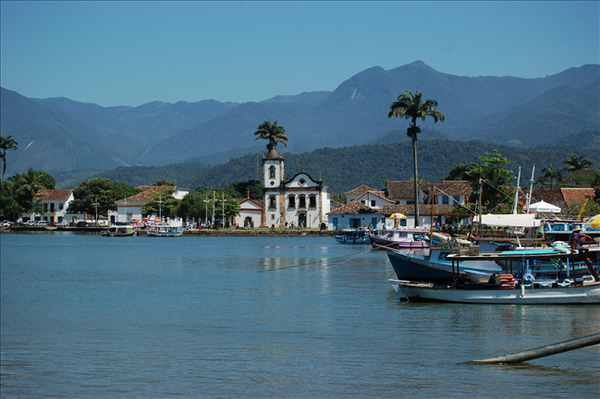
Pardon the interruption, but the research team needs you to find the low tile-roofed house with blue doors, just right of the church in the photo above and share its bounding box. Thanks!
[327,199,387,230]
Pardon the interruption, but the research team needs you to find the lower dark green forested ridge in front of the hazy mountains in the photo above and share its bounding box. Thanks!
[65,132,600,193]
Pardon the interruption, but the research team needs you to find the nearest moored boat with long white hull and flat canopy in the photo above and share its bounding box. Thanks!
[391,249,600,304]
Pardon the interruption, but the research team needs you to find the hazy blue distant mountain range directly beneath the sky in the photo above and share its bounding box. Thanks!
[0,61,600,176]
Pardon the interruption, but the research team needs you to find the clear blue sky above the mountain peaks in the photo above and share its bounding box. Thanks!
[0,0,600,106]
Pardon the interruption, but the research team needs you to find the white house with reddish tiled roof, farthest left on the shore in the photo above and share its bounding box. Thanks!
[21,190,85,224]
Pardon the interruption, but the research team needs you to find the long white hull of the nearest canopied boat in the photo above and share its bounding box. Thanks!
[399,282,600,305]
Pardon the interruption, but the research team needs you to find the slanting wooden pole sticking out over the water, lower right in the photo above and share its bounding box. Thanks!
[463,333,600,364]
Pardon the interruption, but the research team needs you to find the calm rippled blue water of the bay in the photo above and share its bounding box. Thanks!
[0,233,600,398]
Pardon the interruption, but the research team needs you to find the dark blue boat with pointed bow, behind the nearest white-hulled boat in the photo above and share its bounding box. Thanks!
[387,246,502,284]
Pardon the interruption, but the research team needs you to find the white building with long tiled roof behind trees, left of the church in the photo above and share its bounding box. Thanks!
[108,186,189,226]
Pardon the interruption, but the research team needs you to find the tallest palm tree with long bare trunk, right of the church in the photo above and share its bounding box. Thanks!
[388,90,446,226]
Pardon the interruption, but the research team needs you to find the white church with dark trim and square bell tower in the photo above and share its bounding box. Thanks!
[262,146,329,229]
